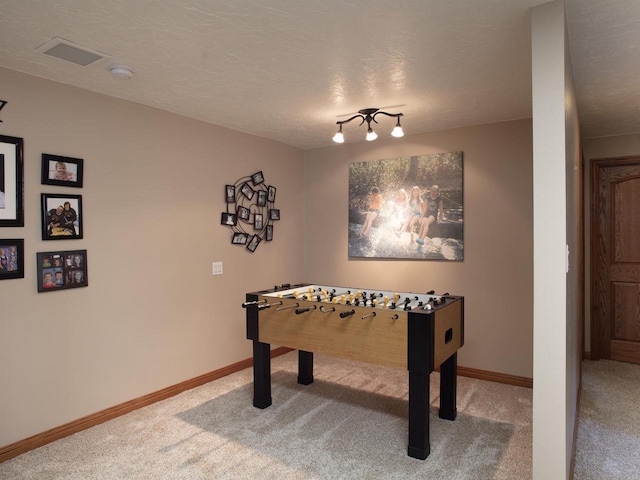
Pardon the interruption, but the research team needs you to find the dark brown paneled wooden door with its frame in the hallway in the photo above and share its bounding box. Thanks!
[591,157,640,363]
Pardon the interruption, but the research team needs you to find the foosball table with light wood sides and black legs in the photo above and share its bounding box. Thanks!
[242,284,464,460]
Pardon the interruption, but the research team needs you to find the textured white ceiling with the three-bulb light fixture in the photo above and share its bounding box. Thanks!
[0,0,640,149]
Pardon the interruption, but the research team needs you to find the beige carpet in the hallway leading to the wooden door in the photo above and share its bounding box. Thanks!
[574,360,640,480]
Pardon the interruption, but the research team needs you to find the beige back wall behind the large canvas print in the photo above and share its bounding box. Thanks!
[304,120,533,378]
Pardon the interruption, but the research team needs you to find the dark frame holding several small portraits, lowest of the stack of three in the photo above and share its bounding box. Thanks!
[36,250,89,292]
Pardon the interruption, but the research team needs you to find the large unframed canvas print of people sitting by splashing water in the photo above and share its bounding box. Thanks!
[348,152,464,261]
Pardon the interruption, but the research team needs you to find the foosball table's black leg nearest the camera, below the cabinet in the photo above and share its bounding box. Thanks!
[408,371,431,460]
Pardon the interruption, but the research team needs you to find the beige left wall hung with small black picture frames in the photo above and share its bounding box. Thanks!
[0,69,304,445]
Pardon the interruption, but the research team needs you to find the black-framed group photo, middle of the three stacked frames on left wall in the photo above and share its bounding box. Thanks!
[42,193,83,240]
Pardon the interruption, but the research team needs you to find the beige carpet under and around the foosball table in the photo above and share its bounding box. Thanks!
[0,352,536,480]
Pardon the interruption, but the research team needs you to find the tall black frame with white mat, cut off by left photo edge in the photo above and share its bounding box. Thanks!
[0,135,24,227]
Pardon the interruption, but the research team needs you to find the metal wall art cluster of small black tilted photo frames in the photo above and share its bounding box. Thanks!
[220,171,280,253]
